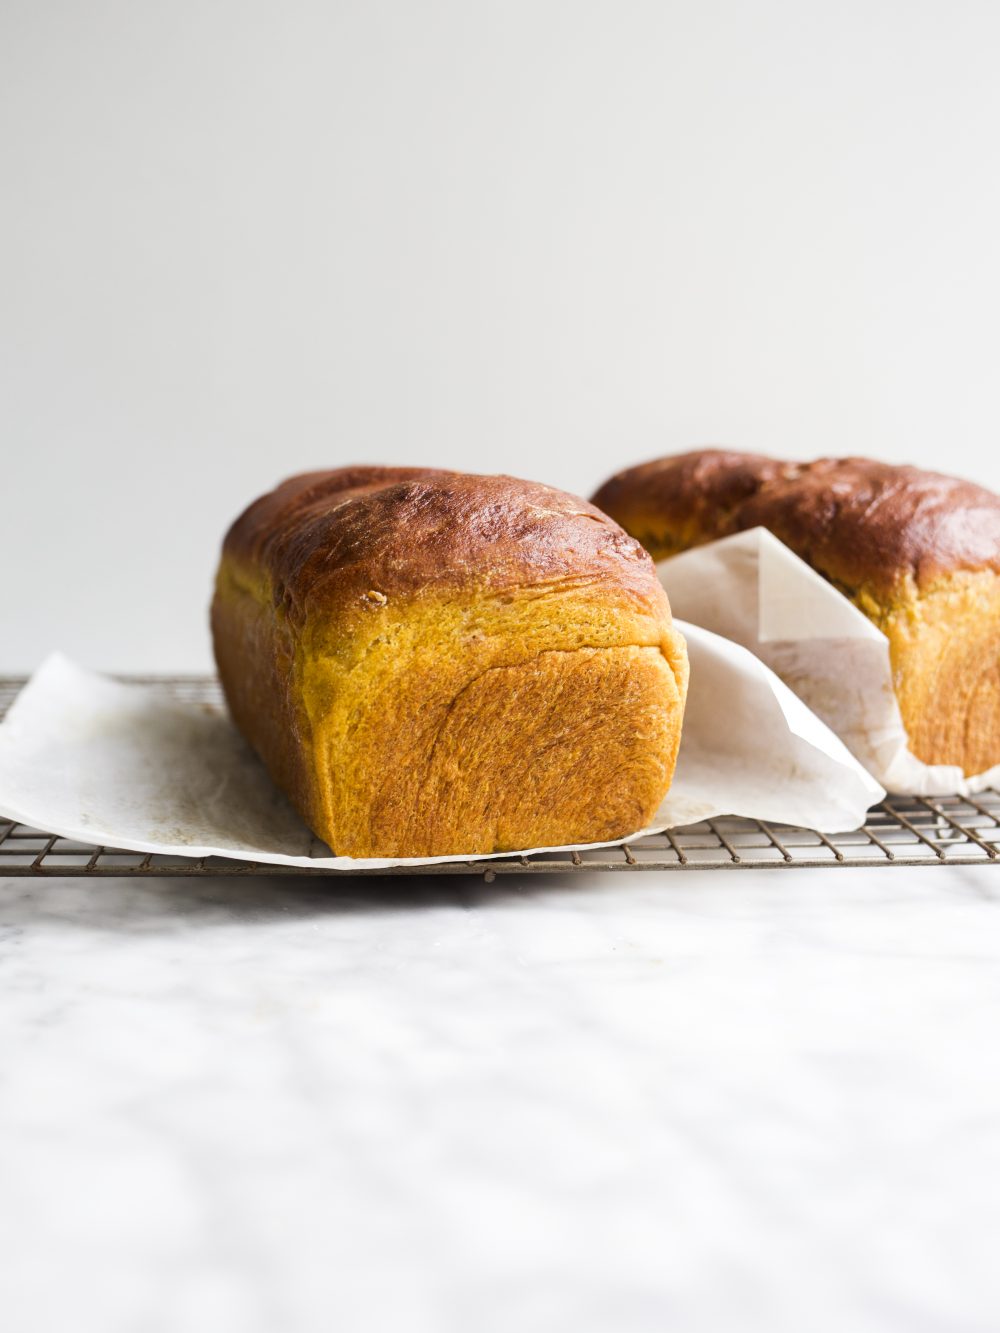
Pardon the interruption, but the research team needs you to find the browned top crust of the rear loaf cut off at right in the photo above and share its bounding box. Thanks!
[593,449,1000,592]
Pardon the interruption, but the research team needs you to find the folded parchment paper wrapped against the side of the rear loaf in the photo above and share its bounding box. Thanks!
[657,528,1000,796]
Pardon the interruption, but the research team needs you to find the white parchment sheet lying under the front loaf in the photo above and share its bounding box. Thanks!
[0,625,884,870]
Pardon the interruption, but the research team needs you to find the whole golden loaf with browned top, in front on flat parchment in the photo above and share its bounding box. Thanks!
[212,467,687,857]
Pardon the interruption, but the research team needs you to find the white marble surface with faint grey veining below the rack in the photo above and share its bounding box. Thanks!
[0,868,1000,1333]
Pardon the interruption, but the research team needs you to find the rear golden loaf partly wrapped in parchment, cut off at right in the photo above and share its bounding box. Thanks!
[593,449,1000,776]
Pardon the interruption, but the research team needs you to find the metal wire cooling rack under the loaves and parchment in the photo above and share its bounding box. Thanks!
[0,676,1000,880]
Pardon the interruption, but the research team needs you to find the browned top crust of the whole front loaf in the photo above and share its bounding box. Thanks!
[224,467,661,619]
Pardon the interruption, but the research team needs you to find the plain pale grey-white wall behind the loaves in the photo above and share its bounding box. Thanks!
[0,0,1000,672]
